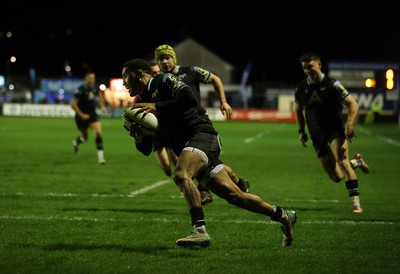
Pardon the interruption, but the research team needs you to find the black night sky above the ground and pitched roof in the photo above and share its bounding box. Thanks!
[0,1,400,83]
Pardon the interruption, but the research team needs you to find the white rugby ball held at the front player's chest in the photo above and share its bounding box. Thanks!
[122,107,158,136]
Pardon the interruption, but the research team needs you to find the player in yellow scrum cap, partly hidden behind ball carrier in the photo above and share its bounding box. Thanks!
[154,44,250,205]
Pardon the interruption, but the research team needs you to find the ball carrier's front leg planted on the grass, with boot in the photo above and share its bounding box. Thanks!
[173,148,211,247]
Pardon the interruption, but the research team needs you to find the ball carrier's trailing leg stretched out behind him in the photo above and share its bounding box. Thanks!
[206,164,297,246]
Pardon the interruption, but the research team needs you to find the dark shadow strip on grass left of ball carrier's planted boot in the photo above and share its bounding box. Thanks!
[43,243,173,254]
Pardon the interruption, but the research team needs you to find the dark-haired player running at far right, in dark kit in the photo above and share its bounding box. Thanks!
[295,52,369,213]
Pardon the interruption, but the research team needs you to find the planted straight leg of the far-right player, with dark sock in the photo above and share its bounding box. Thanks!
[331,137,362,213]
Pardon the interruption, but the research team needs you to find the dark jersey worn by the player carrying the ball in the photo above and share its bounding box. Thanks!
[137,73,218,155]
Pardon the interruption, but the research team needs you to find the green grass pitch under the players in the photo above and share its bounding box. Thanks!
[0,117,400,274]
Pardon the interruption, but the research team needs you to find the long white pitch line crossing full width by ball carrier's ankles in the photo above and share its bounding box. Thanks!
[0,215,400,226]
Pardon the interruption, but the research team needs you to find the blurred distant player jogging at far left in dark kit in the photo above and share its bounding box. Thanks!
[70,72,106,165]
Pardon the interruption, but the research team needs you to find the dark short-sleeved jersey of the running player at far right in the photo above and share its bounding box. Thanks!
[295,74,349,135]
